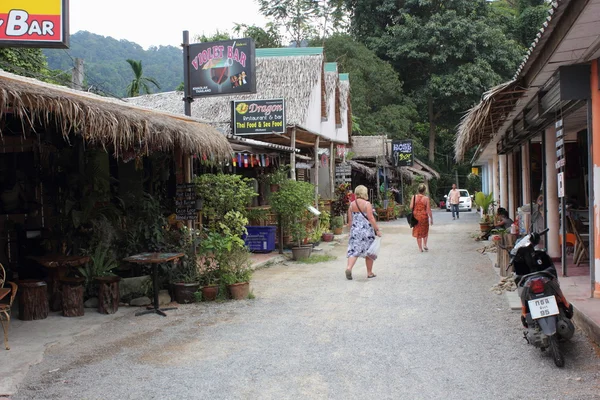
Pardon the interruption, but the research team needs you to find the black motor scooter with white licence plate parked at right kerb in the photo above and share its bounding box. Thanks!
[509,229,575,367]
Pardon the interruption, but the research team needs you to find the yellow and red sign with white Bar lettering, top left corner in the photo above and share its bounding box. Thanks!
[0,0,69,48]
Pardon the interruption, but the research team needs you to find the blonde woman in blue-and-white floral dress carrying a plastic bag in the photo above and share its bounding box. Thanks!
[346,185,381,280]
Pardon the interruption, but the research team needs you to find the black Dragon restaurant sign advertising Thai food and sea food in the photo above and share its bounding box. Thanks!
[231,99,286,135]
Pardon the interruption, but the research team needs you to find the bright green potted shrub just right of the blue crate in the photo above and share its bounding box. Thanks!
[271,180,315,259]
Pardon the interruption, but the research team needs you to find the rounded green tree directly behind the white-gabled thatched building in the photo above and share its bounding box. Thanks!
[315,34,417,138]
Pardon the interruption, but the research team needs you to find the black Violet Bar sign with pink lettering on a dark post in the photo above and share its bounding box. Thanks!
[185,38,256,97]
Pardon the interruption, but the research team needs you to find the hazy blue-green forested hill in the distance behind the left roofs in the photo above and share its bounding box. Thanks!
[43,31,183,97]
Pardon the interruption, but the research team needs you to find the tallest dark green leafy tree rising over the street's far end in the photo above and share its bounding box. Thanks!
[353,0,522,161]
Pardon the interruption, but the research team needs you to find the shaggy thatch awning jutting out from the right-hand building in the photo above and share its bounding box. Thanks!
[454,80,525,161]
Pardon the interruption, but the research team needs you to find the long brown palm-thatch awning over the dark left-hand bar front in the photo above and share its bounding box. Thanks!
[0,70,232,160]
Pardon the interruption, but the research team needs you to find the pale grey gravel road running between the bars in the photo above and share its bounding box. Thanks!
[13,211,600,400]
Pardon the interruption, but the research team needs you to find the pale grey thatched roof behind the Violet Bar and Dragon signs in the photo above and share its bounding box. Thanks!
[127,52,323,132]
